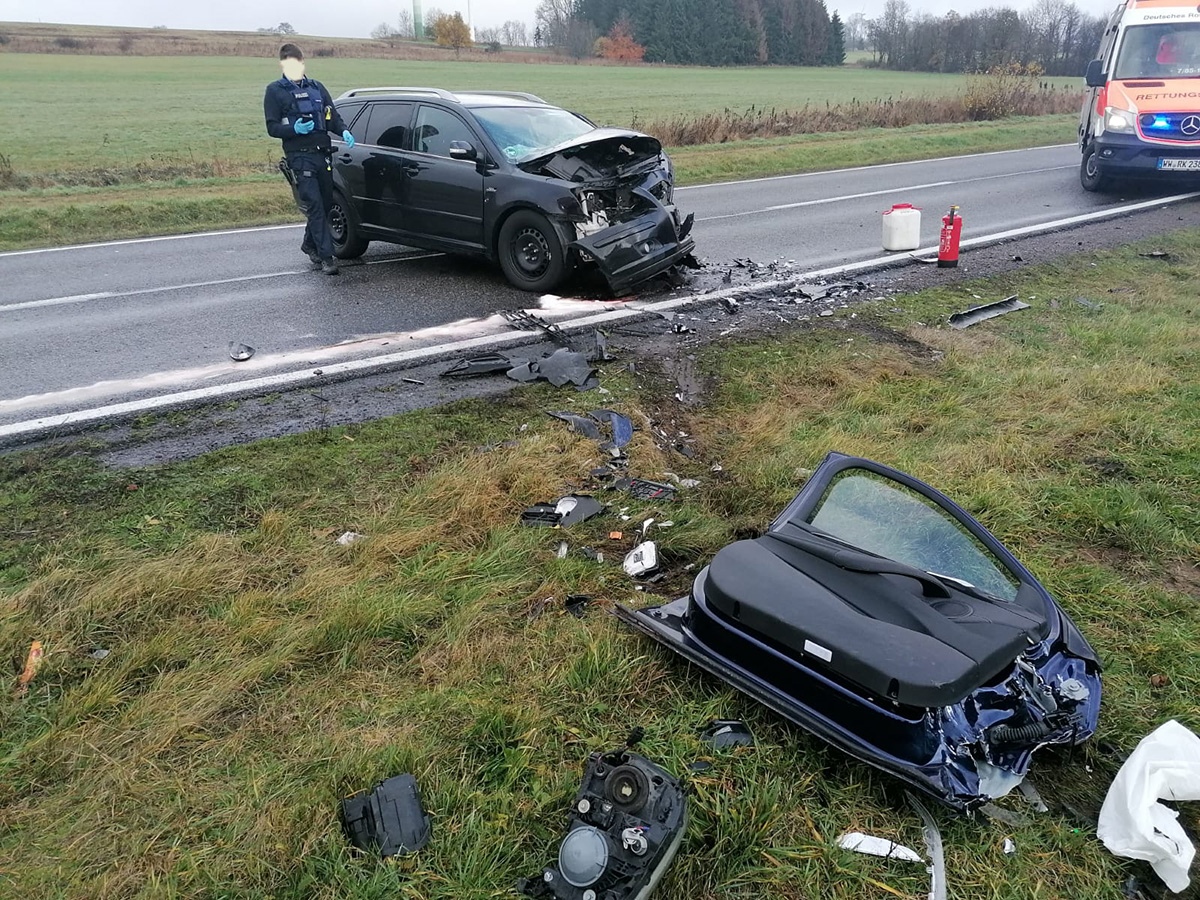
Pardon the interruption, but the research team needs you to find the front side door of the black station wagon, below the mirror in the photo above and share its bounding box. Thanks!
[404,103,485,247]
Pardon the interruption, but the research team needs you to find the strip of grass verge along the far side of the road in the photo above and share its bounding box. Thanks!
[0,116,1074,251]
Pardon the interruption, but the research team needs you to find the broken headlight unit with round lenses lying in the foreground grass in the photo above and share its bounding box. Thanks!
[517,746,688,900]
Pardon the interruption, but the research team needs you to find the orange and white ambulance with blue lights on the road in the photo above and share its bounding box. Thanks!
[1079,0,1200,191]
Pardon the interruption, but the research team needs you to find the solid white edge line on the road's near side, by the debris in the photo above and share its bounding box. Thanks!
[0,191,1200,440]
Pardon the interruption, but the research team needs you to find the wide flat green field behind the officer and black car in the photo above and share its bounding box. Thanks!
[0,53,1080,180]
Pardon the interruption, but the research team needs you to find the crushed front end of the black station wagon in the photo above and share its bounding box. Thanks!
[521,128,695,293]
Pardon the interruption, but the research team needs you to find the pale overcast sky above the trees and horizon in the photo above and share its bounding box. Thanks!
[0,0,1116,37]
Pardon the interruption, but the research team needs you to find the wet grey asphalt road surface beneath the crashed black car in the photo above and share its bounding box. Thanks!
[0,146,1190,425]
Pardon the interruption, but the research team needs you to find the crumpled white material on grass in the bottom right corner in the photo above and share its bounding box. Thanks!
[1096,719,1200,893]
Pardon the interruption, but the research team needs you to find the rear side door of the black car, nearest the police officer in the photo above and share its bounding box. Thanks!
[350,101,413,232]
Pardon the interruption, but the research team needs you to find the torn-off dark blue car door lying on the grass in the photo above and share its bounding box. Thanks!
[616,454,1100,811]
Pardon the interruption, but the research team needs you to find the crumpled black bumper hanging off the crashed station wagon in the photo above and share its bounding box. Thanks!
[570,204,696,294]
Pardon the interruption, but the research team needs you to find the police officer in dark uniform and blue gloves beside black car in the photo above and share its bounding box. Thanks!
[263,43,354,275]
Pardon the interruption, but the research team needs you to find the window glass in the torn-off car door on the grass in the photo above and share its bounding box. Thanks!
[809,469,1020,600]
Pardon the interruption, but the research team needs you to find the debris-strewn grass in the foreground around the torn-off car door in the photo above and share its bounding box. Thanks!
[0,232,1200,900]
